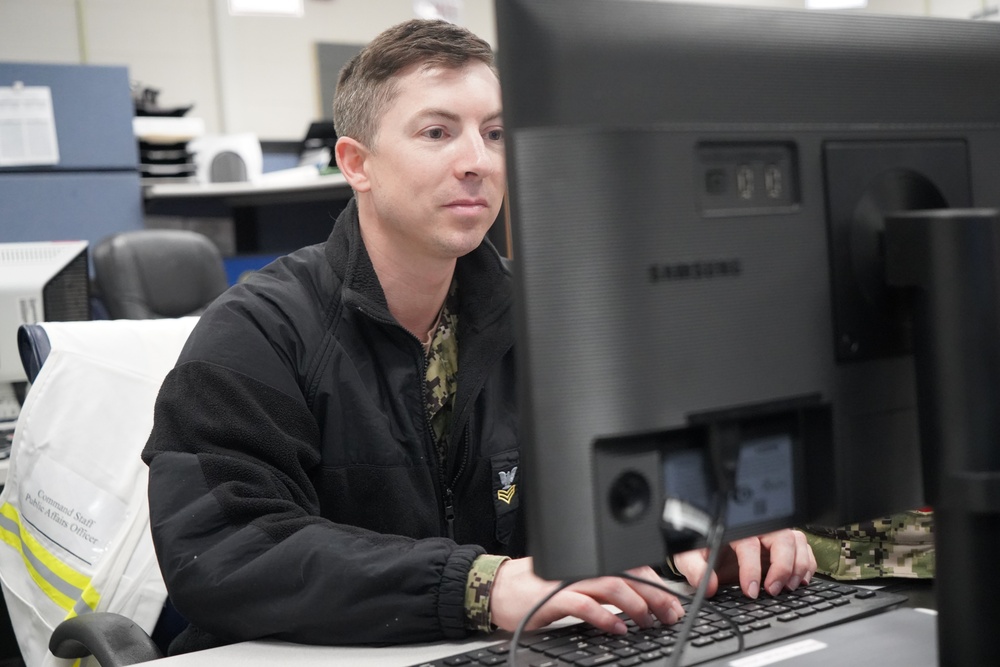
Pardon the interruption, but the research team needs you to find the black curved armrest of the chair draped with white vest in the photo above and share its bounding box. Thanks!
[49,612,163,667]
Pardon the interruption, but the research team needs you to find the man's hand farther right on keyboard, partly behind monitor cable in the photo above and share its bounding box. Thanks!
[674,530,816,599]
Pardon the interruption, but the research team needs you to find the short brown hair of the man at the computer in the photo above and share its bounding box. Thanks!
[333,19,496,148]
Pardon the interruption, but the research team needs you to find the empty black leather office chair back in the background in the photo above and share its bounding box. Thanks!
[93,229,229,320]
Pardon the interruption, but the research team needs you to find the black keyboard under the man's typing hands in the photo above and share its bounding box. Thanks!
[414,580,906,667]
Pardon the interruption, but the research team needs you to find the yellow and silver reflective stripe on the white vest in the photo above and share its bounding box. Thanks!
[0,503,93,611]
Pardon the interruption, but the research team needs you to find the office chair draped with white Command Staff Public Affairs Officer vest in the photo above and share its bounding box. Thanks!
[0,317,197,667]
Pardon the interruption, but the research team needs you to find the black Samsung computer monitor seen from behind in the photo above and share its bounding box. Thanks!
[496,0,1000,579]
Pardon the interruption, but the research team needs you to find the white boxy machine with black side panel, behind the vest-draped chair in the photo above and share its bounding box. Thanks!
[0,241,90,420]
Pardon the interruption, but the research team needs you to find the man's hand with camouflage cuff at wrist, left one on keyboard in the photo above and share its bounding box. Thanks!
[490,558,684,635]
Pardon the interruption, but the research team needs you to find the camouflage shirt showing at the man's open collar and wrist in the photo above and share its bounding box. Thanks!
[424,282,508,632]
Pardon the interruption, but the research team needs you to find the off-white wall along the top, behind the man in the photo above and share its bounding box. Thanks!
[0,0,996,139]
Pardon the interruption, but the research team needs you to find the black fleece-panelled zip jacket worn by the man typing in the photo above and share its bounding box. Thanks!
[143,202,524,653]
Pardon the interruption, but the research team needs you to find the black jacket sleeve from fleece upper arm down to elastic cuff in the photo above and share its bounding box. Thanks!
[143,361,483,644]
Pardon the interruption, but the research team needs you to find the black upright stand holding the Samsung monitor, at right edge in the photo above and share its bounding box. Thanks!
[885,209,1000,665]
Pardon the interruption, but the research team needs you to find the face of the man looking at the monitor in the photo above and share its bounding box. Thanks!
[363,62,506,260]
